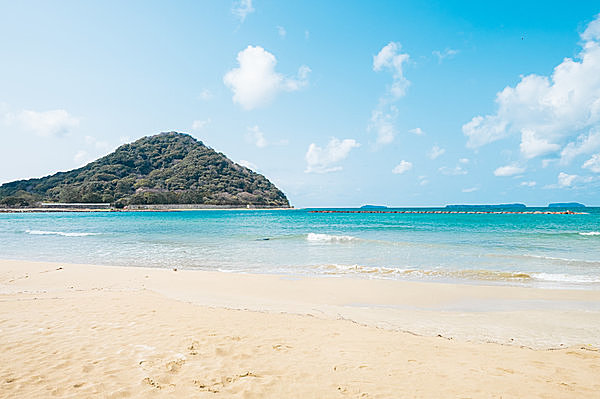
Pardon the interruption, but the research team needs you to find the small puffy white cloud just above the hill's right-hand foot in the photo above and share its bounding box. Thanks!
[305,137,360,173]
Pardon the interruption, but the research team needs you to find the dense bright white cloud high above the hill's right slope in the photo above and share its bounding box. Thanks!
[223,46,311,110]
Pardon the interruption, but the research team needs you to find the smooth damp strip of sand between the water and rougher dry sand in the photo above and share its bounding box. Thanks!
[0,260,600,349]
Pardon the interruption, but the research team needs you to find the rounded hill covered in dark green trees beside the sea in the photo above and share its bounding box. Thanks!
[0,132,289,207]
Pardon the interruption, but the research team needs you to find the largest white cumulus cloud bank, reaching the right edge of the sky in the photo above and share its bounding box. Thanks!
[462,15,600,159]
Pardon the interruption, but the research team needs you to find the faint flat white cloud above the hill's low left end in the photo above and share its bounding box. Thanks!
[13,109,79,137]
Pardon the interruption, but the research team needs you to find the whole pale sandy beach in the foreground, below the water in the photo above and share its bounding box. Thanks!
[0,261,600,398]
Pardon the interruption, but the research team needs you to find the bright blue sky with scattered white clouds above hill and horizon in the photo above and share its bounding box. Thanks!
[0,0,600,207]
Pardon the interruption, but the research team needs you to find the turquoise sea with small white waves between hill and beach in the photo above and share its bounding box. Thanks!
[0,208,600,289]
